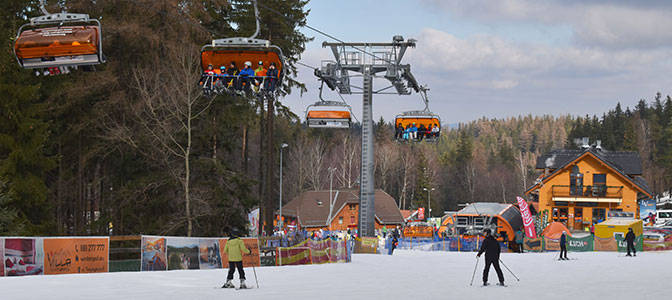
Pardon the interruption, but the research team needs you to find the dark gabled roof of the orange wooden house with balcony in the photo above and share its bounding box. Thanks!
[525,147,652,196]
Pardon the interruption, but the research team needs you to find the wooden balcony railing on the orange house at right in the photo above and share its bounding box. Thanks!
[551,185,623,202]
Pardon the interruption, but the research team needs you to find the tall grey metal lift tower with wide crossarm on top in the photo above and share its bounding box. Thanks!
[315,35,420,236]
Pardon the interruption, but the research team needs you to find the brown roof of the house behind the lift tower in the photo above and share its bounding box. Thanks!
[275,189,404,227]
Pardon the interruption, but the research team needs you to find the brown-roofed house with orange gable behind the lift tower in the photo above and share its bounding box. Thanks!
[275,189,404,231]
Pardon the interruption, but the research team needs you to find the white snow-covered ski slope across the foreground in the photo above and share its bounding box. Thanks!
[0,250,672,300]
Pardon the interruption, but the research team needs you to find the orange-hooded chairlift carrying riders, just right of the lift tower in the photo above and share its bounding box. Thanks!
[394,86,441,142]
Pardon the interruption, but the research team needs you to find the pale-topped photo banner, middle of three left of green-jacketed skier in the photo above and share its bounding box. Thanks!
[166,237,200,270]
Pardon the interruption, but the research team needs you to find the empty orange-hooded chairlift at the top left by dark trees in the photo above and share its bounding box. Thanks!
[14,0,105,69]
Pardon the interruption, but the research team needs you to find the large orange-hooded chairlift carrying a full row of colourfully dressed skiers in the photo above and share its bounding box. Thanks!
[201,1,285,92]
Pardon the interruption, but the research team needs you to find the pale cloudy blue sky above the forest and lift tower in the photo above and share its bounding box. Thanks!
[283,0,672,124]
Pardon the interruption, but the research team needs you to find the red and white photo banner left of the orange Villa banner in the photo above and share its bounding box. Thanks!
[4,238,44,276]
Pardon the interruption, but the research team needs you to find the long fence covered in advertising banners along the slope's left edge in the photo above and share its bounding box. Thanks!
[0,235,352,276]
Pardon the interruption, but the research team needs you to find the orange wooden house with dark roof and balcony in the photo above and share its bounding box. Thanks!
[525,146,652,230]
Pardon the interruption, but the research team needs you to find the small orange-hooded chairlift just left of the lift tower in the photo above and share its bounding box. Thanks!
[306,81,352,129]
